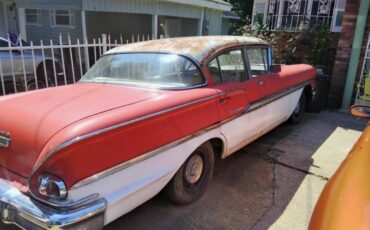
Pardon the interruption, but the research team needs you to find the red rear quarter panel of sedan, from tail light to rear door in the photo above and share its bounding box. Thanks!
[31,86,219,187]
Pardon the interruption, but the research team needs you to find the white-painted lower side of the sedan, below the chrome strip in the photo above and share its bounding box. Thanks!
[68,88,303,224]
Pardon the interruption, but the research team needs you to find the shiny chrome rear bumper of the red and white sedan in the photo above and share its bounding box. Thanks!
[0,179,106,229]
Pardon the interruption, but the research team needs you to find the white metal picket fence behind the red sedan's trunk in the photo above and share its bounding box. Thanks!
[0,35,151,95]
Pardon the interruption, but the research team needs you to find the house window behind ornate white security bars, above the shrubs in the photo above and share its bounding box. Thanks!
[266,0,345,31]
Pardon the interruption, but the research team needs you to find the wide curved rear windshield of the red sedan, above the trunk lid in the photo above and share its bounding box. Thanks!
[81,53,205,89]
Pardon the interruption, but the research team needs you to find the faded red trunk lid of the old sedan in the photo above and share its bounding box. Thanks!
[0,83,159,177]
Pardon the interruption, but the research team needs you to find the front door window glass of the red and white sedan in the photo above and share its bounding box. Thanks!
[246,47,268,76]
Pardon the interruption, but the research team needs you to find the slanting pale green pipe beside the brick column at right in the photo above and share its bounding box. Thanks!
[341,0,370,111]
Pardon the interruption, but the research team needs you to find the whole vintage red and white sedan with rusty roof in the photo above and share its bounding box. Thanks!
[0,36,316,229]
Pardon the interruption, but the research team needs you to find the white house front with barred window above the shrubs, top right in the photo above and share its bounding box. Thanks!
[252,0,346,32]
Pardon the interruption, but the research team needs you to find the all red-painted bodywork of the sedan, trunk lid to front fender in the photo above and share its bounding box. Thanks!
[0,36,316,194]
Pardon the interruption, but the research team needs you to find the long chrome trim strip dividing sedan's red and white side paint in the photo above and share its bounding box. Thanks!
[71,81,311,190]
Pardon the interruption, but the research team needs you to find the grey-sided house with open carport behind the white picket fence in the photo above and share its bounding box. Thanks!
[0,0,232,43]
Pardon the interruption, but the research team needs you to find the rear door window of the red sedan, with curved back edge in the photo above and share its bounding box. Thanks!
[208,50,246,82]
